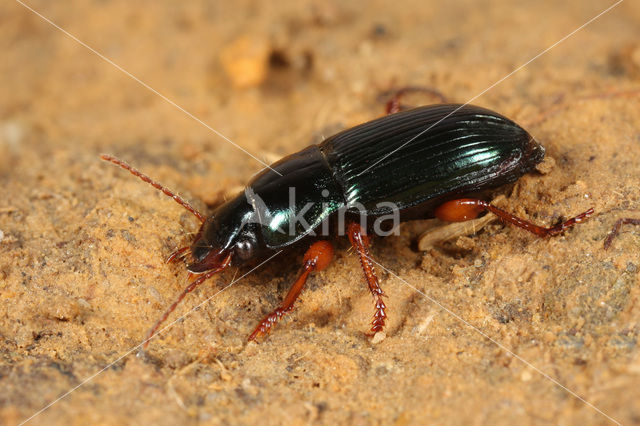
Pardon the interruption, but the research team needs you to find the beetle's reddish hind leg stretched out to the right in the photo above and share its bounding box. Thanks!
[435,198,593,237]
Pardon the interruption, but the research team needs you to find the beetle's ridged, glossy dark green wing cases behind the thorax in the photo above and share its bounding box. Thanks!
[321,104,544,215]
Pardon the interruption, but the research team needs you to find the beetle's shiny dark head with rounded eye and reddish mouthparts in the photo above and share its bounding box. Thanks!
[187,196,262,273]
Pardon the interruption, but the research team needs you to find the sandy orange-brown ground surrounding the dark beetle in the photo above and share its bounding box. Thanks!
[0,0,640,425]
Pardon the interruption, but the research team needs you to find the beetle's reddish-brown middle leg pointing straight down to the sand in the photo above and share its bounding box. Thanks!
[347,222,387,333]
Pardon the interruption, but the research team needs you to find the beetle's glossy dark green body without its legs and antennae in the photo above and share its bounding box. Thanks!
[189,104,544,266]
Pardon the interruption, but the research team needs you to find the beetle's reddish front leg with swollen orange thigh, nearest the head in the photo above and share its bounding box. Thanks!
[249,240,333,341]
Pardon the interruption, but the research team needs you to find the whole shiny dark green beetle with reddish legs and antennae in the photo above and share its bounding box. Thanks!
[101,104,593,347]
